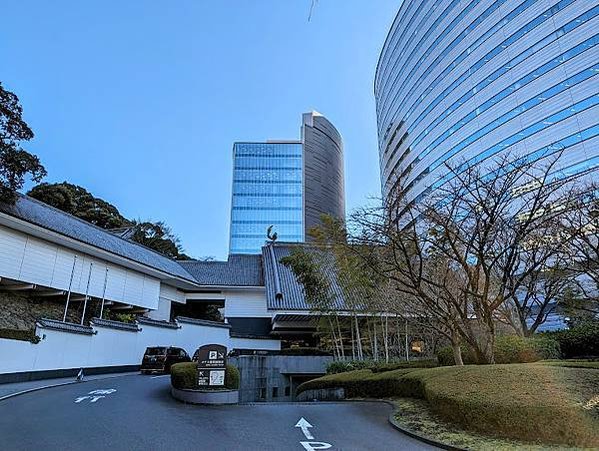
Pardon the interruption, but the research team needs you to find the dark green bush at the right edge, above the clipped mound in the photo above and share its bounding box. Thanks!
[543,320,599,359]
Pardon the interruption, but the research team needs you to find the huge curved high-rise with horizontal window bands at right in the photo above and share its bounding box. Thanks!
[375,0,599,205]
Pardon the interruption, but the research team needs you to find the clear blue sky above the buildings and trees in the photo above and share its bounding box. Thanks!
[0,0,401,258]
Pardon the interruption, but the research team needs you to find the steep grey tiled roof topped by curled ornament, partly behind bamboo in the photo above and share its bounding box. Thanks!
[262,243,345,310]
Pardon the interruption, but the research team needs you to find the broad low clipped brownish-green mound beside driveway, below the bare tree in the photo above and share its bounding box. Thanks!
[300,362,599,447]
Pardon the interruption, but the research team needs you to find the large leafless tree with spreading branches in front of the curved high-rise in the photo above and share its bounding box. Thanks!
[352,153,571,363]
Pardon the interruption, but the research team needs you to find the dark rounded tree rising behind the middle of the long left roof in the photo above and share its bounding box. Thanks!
[27,182,132,229]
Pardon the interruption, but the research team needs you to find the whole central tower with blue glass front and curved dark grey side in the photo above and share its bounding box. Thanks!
[229,112,345,254]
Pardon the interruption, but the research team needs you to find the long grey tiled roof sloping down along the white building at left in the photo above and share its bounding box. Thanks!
[0,195,193,281]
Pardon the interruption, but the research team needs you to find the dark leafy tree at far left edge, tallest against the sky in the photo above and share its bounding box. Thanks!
[0,83,46,203]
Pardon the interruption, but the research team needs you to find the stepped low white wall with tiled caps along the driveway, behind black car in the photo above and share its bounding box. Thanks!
[0,318,280,380]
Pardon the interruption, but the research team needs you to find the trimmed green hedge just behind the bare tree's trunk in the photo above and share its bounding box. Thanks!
[437,335,561,366]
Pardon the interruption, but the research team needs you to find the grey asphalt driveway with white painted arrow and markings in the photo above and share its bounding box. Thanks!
[0,375,440,451]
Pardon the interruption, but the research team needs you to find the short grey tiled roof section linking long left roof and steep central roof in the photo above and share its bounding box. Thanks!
[179,254,264,287]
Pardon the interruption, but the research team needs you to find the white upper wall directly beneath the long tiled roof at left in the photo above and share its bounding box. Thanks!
[0,226,161,310]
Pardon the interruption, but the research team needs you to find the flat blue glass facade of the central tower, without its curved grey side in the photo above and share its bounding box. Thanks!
[229,142,304,254]
